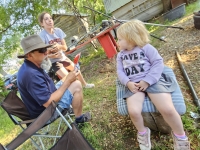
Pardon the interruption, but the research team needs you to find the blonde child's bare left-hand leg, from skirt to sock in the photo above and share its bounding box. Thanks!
[126,92,146,132]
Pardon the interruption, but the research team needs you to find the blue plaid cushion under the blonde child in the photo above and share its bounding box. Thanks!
[116,66,186,115]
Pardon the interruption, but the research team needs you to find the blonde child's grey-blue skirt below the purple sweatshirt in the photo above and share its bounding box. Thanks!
[123,73,177,99]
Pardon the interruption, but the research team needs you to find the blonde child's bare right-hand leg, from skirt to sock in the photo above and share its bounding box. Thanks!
[148,93,185,135]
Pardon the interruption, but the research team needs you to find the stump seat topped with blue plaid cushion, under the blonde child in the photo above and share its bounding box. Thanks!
[116,66,186,133]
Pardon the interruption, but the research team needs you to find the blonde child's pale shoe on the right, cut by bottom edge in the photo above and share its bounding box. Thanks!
[171,132,190,150]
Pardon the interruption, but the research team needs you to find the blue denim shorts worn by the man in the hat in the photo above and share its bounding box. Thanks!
[55,81,73,109]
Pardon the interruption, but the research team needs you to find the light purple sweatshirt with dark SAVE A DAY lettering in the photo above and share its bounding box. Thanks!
[117,44,164,86]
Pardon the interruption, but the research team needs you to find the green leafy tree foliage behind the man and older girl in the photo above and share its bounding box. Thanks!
[0,0,105,68]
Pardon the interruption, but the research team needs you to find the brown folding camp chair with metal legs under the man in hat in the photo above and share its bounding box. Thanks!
[0,91,93,150]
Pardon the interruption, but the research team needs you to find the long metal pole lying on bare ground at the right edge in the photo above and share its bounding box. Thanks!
[176,51,200,108]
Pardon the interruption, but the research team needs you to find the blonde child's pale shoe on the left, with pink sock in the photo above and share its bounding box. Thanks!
[137,127,151,150]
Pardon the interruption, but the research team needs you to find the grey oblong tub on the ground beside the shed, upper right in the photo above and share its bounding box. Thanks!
[162,3,185,21]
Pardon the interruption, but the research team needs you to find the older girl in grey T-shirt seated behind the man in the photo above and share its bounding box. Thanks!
[38,12,94,88]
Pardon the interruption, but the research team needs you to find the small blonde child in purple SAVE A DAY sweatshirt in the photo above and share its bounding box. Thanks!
[117,20,190,150]
